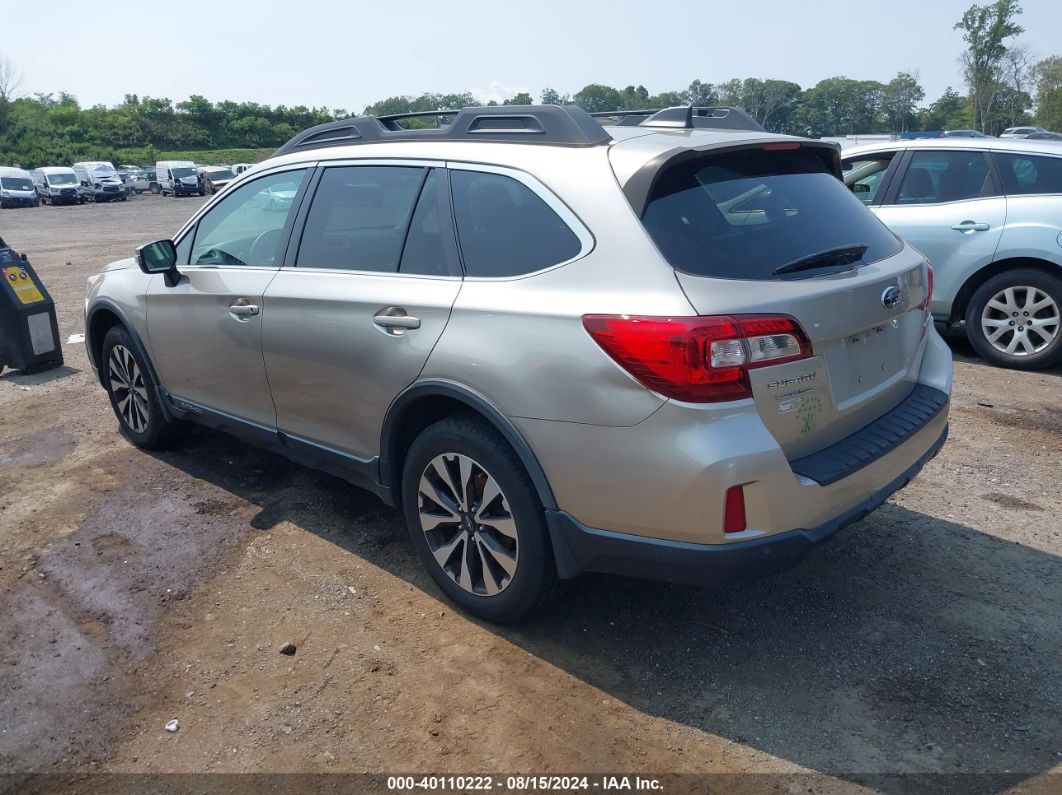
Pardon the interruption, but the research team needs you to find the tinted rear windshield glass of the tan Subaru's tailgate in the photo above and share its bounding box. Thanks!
[643,150,902,279]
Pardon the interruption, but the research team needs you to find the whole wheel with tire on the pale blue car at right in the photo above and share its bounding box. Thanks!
[966,267,1062,369]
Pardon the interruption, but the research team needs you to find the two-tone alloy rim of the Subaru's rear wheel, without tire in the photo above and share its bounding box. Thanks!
[417,453,519,597]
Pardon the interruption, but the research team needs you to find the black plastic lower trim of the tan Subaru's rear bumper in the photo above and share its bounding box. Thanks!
[546,426,947,585]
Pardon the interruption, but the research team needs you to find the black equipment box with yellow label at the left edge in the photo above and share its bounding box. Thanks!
[0,238,63,373]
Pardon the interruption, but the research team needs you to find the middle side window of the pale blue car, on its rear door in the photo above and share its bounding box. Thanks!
[895,151,995,204]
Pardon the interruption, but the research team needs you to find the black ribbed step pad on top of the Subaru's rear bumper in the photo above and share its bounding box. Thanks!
[789,384,947,486]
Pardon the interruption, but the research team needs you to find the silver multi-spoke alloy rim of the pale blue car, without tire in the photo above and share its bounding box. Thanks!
[981,286,1062,357]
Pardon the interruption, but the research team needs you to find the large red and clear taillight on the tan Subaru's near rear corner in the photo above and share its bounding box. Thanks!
[583,314,811,403]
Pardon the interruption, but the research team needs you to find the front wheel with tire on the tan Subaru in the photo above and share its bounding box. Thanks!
[100,326,184,450]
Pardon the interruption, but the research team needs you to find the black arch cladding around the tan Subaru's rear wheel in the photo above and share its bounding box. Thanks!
[380,381,556,509]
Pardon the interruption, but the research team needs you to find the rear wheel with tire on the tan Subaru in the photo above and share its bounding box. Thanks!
[401,416,559,623]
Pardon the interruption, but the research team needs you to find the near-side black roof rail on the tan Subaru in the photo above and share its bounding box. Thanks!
[271,105,612,157]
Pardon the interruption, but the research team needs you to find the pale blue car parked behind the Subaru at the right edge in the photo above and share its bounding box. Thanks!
[844,138,1062,369]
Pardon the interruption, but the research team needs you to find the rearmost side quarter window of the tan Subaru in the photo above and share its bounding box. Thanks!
[450,170,582,277]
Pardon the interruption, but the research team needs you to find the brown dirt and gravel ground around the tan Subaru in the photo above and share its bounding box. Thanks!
[0,196,1062,792]
